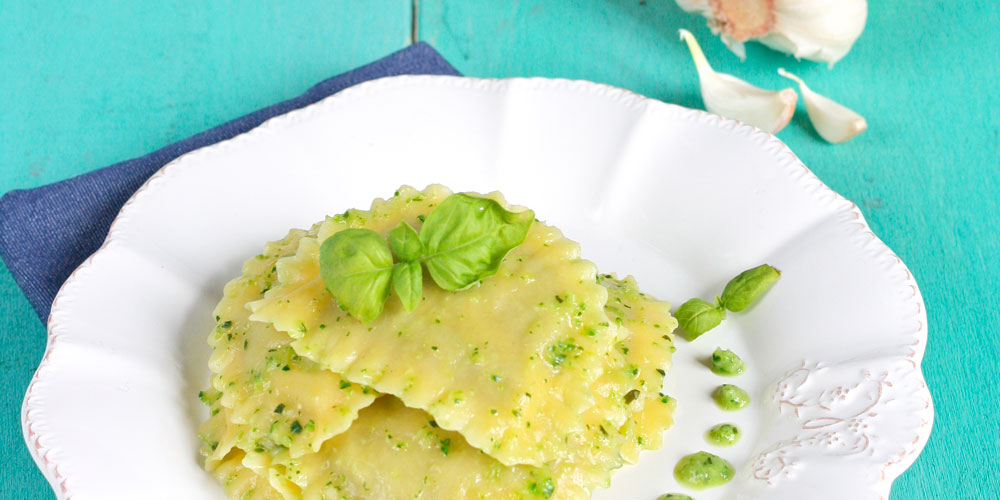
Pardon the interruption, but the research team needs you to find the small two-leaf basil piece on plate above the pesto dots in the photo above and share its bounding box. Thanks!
[674,264,781,340]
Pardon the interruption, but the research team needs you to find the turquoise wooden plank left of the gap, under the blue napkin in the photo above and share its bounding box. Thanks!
[0,0,411,500]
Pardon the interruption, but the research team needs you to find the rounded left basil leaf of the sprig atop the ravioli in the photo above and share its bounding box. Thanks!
[319,229,393,322]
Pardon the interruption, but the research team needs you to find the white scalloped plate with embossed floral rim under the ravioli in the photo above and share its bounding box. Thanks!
[23,76,933,500]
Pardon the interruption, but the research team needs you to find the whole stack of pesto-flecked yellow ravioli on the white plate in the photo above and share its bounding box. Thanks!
[199,186,677,500]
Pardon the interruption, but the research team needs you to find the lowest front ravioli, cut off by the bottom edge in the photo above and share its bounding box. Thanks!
[289,396,560,500]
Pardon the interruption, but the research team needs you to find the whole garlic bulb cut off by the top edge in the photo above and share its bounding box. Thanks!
[677,0,868,66]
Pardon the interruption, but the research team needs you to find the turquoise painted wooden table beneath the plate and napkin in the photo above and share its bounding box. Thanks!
[0,0,1000,500]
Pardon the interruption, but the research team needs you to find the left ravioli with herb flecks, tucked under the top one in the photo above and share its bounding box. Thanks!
[203,230,376,460]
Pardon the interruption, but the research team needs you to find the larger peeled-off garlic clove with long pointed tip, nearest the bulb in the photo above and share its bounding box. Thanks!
[680,30,799,134]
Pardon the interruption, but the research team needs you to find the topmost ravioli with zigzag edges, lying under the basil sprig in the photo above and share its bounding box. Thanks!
[250,186,618,465]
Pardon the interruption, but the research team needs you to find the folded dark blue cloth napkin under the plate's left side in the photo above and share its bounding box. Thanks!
[0,43,458,321]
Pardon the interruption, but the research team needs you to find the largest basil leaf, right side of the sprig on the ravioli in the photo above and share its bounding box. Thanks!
[420,194,535,291]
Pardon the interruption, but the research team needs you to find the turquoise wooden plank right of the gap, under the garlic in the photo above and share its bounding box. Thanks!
[420,0,1000,500]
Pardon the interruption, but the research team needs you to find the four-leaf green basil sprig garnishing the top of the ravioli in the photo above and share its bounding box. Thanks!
[319,194,535,322]
